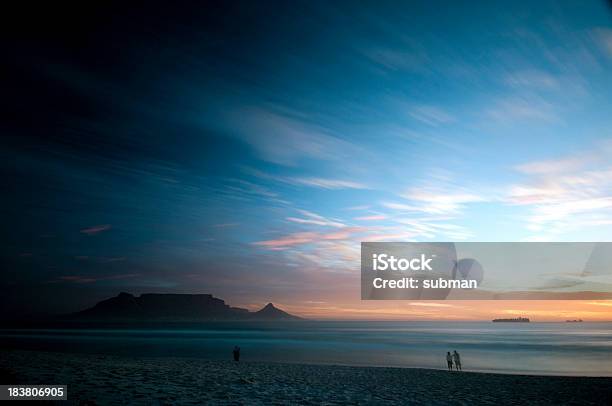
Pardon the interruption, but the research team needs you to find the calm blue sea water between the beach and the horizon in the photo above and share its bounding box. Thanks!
[0,321,612,376]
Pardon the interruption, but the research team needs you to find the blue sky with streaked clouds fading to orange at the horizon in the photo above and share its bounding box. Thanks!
[0,1,612,320]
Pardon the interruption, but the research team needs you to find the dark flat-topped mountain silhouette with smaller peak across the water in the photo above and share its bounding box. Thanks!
[70,292,300,321]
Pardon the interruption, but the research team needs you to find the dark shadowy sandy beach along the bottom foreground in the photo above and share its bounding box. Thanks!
[0,351,612,405]
